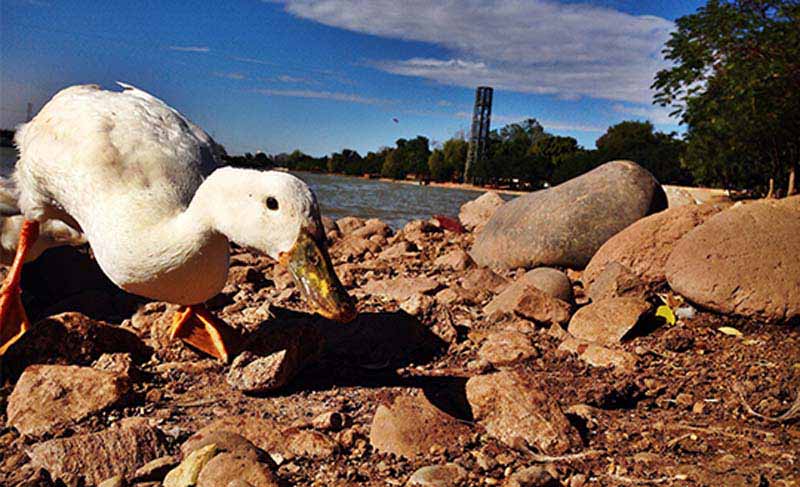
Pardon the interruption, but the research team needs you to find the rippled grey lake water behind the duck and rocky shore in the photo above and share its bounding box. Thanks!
[0,147,507,229]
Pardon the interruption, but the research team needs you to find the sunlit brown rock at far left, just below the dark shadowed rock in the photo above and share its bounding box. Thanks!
[8,365,128,436]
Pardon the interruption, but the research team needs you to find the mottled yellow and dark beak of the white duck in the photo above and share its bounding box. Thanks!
[280,228,356,323]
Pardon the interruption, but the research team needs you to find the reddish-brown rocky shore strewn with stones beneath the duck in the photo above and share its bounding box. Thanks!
[0,177,800,487]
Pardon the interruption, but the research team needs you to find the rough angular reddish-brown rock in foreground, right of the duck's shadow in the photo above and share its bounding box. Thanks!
[467,371,581,454]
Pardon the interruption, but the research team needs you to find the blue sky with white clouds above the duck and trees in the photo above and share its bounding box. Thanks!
[0,0,704,155]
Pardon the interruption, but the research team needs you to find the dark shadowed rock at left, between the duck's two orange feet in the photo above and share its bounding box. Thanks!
[3,312,152,377]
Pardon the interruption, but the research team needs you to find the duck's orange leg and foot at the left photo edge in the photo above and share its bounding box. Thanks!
[0,220,39,357]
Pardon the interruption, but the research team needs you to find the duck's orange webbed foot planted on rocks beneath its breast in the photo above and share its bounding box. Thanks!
[170,304,241,363]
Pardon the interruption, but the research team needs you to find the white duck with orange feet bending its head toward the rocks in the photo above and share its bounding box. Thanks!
[0,83,355,361]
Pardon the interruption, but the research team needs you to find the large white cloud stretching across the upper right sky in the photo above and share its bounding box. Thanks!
[282,0,674,103]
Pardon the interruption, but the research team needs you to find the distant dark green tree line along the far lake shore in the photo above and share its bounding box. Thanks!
[228,118,691,189]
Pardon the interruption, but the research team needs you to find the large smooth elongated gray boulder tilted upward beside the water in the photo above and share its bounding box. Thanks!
[470,161,667,269]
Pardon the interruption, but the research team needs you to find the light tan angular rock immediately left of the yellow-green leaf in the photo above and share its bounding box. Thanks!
[567,298,650,345]
